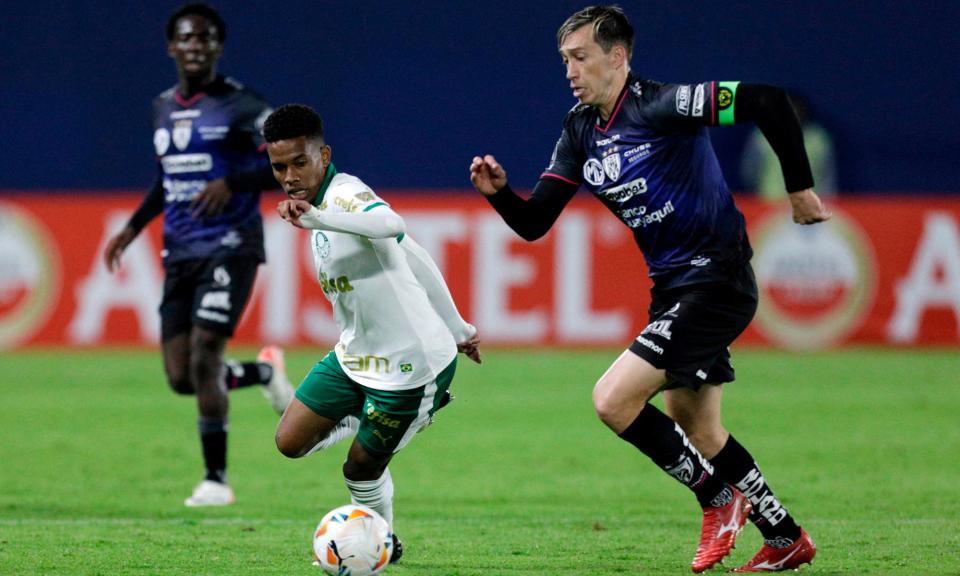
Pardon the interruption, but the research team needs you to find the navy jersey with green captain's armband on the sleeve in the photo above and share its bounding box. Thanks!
[541,76,752,287]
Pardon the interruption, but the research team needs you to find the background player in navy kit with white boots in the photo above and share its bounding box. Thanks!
[104,4,293,506]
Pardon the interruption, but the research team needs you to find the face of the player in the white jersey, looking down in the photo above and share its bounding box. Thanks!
[267,136,330,204]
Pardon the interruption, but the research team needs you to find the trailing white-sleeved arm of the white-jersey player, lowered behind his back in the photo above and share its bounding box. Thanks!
[400,235,480,364]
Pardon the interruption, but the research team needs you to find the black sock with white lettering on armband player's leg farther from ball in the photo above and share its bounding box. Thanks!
[710,436,800,546]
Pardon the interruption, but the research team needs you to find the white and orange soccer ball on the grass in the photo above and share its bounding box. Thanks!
[313,504,393,576]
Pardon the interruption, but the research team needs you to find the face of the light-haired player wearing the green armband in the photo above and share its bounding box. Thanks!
[560,25,625,112]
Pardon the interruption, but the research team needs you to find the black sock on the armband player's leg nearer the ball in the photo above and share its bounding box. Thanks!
[620,404,733,506]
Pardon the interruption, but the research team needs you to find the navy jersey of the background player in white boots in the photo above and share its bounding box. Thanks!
[153,77,271,264]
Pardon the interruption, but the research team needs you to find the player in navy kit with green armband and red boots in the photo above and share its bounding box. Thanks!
[470,6,830,572]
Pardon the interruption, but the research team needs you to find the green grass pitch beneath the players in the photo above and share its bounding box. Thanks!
[0,350,960,576]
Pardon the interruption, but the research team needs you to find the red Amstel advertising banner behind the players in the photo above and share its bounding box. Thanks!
[0,191,960,349]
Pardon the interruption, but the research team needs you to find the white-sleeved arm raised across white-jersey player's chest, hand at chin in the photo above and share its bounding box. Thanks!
[277,199,406,238]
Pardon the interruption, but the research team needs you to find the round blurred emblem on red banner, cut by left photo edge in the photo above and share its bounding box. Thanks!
[0,202,60,349]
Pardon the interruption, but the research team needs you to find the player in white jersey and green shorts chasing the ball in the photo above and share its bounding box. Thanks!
[263,104,480,562]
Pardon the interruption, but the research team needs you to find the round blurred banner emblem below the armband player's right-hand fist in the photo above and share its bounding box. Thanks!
[753,206,877,350]
